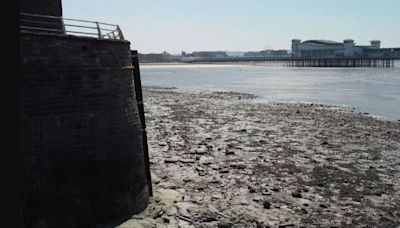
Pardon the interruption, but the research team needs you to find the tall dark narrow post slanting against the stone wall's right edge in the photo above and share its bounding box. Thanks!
[131,51,153,196]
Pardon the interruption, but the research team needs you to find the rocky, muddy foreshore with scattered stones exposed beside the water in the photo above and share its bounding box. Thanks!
[119,87,400,228]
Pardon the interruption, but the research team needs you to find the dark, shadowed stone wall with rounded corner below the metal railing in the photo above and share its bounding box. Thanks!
[20,33,149,227]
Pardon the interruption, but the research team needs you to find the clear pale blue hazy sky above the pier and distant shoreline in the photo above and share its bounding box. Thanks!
[62,0,400,53]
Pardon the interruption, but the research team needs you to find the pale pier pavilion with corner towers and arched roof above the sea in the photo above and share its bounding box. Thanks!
[292,39,399,58]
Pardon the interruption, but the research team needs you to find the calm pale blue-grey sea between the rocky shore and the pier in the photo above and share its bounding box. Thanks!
[140,64,400,120]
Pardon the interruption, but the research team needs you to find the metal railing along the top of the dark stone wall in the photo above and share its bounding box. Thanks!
[20,13,124,40]
